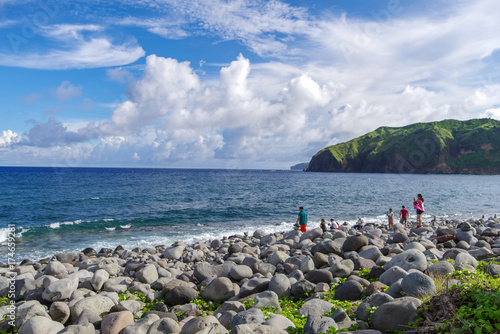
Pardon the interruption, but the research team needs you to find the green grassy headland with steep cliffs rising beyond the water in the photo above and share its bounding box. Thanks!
[307,119,500,174]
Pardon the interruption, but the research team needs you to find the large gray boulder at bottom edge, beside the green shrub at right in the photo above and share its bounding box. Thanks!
[370,297,419,333]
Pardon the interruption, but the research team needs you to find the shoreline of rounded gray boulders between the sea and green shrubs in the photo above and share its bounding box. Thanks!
[0,217,500,334]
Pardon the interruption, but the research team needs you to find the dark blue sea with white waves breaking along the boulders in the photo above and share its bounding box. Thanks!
[0,167,500,262]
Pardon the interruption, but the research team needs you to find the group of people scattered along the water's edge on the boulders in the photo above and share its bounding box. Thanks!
[297,194,425,233]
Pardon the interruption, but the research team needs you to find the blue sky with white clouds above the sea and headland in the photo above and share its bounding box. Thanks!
[0,0,500,169]
